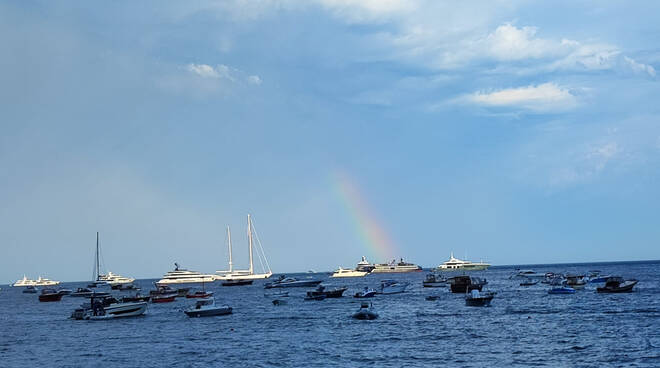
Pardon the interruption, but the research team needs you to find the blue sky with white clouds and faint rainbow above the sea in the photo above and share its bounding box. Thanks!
[0,0,660,283]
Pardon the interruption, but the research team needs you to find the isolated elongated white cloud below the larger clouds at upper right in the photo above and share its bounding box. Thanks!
[459,83,577,112]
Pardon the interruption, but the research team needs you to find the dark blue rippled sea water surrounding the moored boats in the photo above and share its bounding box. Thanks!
[0,261,660,367]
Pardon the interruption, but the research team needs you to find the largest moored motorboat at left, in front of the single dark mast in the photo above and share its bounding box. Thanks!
[71,297,147,320]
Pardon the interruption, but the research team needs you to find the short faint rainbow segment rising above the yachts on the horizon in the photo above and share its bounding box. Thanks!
[332,171,398,263]
